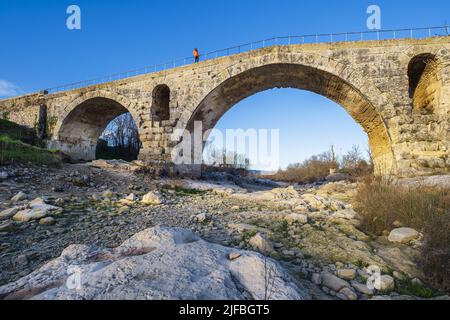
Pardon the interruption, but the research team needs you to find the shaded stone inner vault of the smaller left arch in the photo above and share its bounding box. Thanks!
[58,97,137,161]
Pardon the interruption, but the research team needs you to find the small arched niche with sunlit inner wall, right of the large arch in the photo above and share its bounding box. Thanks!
[408,53,440,113]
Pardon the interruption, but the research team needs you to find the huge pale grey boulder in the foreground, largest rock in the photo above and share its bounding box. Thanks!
[0,227,310,300]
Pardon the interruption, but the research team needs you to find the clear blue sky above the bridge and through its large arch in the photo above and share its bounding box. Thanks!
[0,0,450,169]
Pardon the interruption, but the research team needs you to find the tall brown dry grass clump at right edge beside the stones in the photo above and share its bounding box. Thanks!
[354,178,450,292]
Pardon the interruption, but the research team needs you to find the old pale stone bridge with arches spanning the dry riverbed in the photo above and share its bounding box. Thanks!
[0,36,450,176]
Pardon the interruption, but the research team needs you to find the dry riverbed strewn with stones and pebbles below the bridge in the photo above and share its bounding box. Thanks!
[0,161,448,300]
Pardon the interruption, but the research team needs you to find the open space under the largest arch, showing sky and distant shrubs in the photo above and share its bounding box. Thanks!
[203,88,370,175]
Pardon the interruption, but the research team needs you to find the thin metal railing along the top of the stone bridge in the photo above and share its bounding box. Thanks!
[32,26,450,94]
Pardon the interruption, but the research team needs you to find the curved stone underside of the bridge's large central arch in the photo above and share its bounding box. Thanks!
[181,63,395,174]
